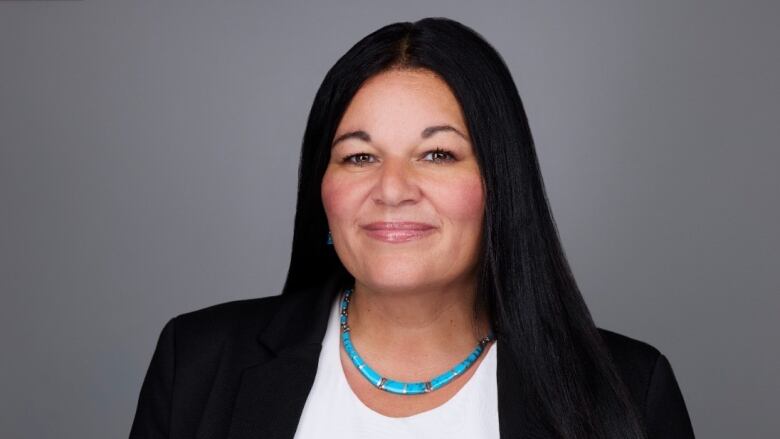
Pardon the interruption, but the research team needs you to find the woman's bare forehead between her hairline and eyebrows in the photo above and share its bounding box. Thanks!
[337,69,466,134]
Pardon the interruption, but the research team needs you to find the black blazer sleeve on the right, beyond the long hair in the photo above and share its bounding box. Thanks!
[645,354,694,439]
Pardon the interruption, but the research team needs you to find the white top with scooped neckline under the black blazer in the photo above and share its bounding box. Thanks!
[295,295,499,439]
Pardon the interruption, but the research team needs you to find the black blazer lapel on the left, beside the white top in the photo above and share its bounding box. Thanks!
[228,278,340,439]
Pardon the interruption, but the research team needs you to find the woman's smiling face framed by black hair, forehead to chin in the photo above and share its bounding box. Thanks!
[322,70,484,290]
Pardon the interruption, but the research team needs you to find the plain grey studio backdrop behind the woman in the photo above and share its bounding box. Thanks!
[0,0,780,438]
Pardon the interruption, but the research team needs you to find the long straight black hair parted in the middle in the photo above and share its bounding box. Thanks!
[283,18,644,439]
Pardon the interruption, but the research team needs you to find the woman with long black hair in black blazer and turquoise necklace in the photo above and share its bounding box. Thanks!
[131,18,693,438]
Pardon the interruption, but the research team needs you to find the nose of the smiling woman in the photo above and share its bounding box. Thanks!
[372,158,420,206]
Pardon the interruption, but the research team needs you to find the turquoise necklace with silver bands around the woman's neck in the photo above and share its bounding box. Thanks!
[340,288,495,395]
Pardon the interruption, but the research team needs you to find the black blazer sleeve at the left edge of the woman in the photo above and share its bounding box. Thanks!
[130,318,176,439]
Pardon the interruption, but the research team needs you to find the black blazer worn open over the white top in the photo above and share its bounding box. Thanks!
[130,274,694,439]
